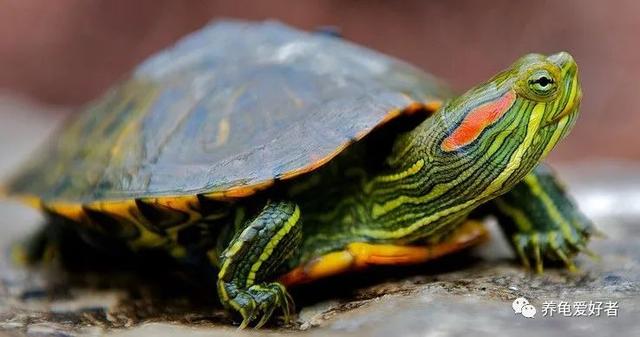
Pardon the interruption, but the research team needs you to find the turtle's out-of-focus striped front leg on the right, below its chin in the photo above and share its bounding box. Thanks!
[491,165,595,273]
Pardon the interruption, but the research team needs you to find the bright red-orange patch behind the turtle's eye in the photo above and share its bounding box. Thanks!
[441,90,516,152]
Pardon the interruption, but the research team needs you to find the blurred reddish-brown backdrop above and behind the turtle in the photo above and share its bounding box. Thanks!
[0,0,640,160]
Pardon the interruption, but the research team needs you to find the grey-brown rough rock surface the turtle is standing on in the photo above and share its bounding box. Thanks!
[0,96,640,337]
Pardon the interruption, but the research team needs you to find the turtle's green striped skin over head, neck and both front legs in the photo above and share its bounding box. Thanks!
[20,53,590,327]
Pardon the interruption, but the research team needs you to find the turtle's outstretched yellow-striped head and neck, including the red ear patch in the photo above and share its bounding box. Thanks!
[352,53,581,241]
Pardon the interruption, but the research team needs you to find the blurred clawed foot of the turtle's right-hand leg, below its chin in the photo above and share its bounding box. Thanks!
[511,227,597,273]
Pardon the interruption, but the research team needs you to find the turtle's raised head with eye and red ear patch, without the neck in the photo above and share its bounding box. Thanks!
[428,52,582,197]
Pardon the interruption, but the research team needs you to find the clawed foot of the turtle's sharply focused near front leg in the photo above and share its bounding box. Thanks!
[226,282,295,329]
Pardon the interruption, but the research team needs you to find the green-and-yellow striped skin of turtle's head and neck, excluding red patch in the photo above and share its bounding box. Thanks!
[296,53,581,260]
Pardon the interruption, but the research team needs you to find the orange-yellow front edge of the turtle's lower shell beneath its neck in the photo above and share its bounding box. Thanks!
[280,220,488,286]
